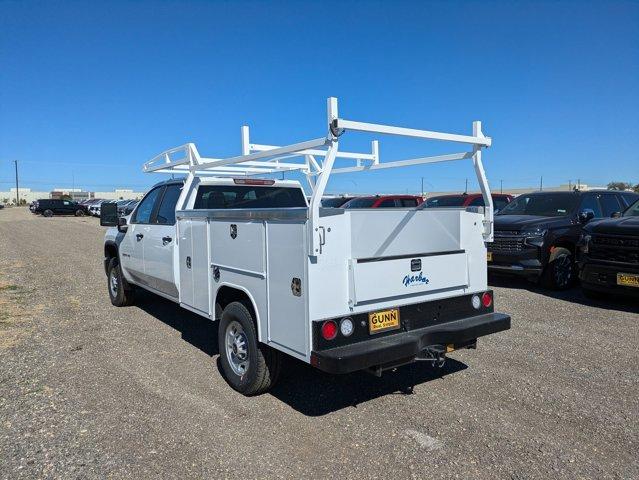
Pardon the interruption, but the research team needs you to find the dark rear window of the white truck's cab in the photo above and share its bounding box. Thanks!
[193,185,306,209]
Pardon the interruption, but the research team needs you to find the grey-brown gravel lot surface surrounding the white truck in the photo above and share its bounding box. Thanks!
[0,209,639,479]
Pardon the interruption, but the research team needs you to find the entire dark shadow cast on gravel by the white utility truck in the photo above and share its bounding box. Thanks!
[135,292,468,417]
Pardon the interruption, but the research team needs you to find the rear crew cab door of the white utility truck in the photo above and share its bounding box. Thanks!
[144,184,182,298]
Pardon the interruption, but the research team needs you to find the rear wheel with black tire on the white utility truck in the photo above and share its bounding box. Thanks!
[218,302,282,396]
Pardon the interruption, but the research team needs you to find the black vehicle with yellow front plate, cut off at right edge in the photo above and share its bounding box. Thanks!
[579,201,639,298]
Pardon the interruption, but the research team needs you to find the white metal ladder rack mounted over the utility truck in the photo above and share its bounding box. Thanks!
[143,97,493,249]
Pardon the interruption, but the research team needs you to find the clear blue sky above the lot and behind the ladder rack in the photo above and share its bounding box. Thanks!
[0,0,639,193]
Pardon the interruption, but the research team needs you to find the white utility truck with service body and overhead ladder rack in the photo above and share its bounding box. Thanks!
[101,98,510,395]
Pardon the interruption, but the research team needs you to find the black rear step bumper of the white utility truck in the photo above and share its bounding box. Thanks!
[311,313,510,373]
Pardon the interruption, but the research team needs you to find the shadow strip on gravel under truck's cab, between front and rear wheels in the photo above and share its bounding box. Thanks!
[135,291,218,356]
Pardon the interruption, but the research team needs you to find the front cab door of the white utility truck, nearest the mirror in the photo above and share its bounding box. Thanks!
[120,185,164,287]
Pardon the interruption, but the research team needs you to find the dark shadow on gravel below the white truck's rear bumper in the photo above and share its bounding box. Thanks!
[270,358,468,417]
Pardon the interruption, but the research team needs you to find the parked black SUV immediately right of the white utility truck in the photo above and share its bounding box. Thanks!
[488,190,639,290]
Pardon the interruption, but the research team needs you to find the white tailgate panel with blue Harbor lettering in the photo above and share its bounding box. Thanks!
[349,250,469,304]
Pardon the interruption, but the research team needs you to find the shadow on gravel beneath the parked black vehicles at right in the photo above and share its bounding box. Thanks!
[488,274,639,313]
